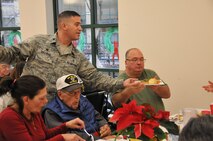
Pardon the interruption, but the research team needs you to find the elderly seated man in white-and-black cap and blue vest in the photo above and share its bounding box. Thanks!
[42,74,111,140]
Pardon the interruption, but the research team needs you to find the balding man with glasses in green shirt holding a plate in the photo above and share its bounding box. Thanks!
[112,48,171,111]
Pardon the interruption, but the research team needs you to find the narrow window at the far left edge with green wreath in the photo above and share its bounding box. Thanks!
[0,0,21,46]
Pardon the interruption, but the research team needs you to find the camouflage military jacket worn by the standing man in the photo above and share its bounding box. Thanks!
[0,34,123,99]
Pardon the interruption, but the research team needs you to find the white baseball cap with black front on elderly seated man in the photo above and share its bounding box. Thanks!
[56,74,83,92]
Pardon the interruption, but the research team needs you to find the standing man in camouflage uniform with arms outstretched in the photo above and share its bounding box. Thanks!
[0,11,144,100]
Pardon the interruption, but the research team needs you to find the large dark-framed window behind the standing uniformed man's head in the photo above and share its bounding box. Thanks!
[53,0,119,77]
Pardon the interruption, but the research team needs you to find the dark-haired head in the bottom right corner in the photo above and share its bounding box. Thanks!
[179,115,213,141]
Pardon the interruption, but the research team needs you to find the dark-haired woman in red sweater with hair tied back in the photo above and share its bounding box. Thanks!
[0,75,85,141]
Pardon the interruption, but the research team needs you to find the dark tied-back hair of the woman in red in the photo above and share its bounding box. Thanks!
[0,75,46,113]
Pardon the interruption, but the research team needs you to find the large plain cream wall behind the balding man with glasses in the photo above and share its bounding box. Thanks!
[118,0,213,113]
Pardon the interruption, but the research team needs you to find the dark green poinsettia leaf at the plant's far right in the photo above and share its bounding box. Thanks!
[159,120,179,135]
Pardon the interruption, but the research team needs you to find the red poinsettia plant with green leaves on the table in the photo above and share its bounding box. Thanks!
[110,100,179,141]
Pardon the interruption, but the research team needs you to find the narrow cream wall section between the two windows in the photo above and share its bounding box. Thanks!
[19,0,54,39]
